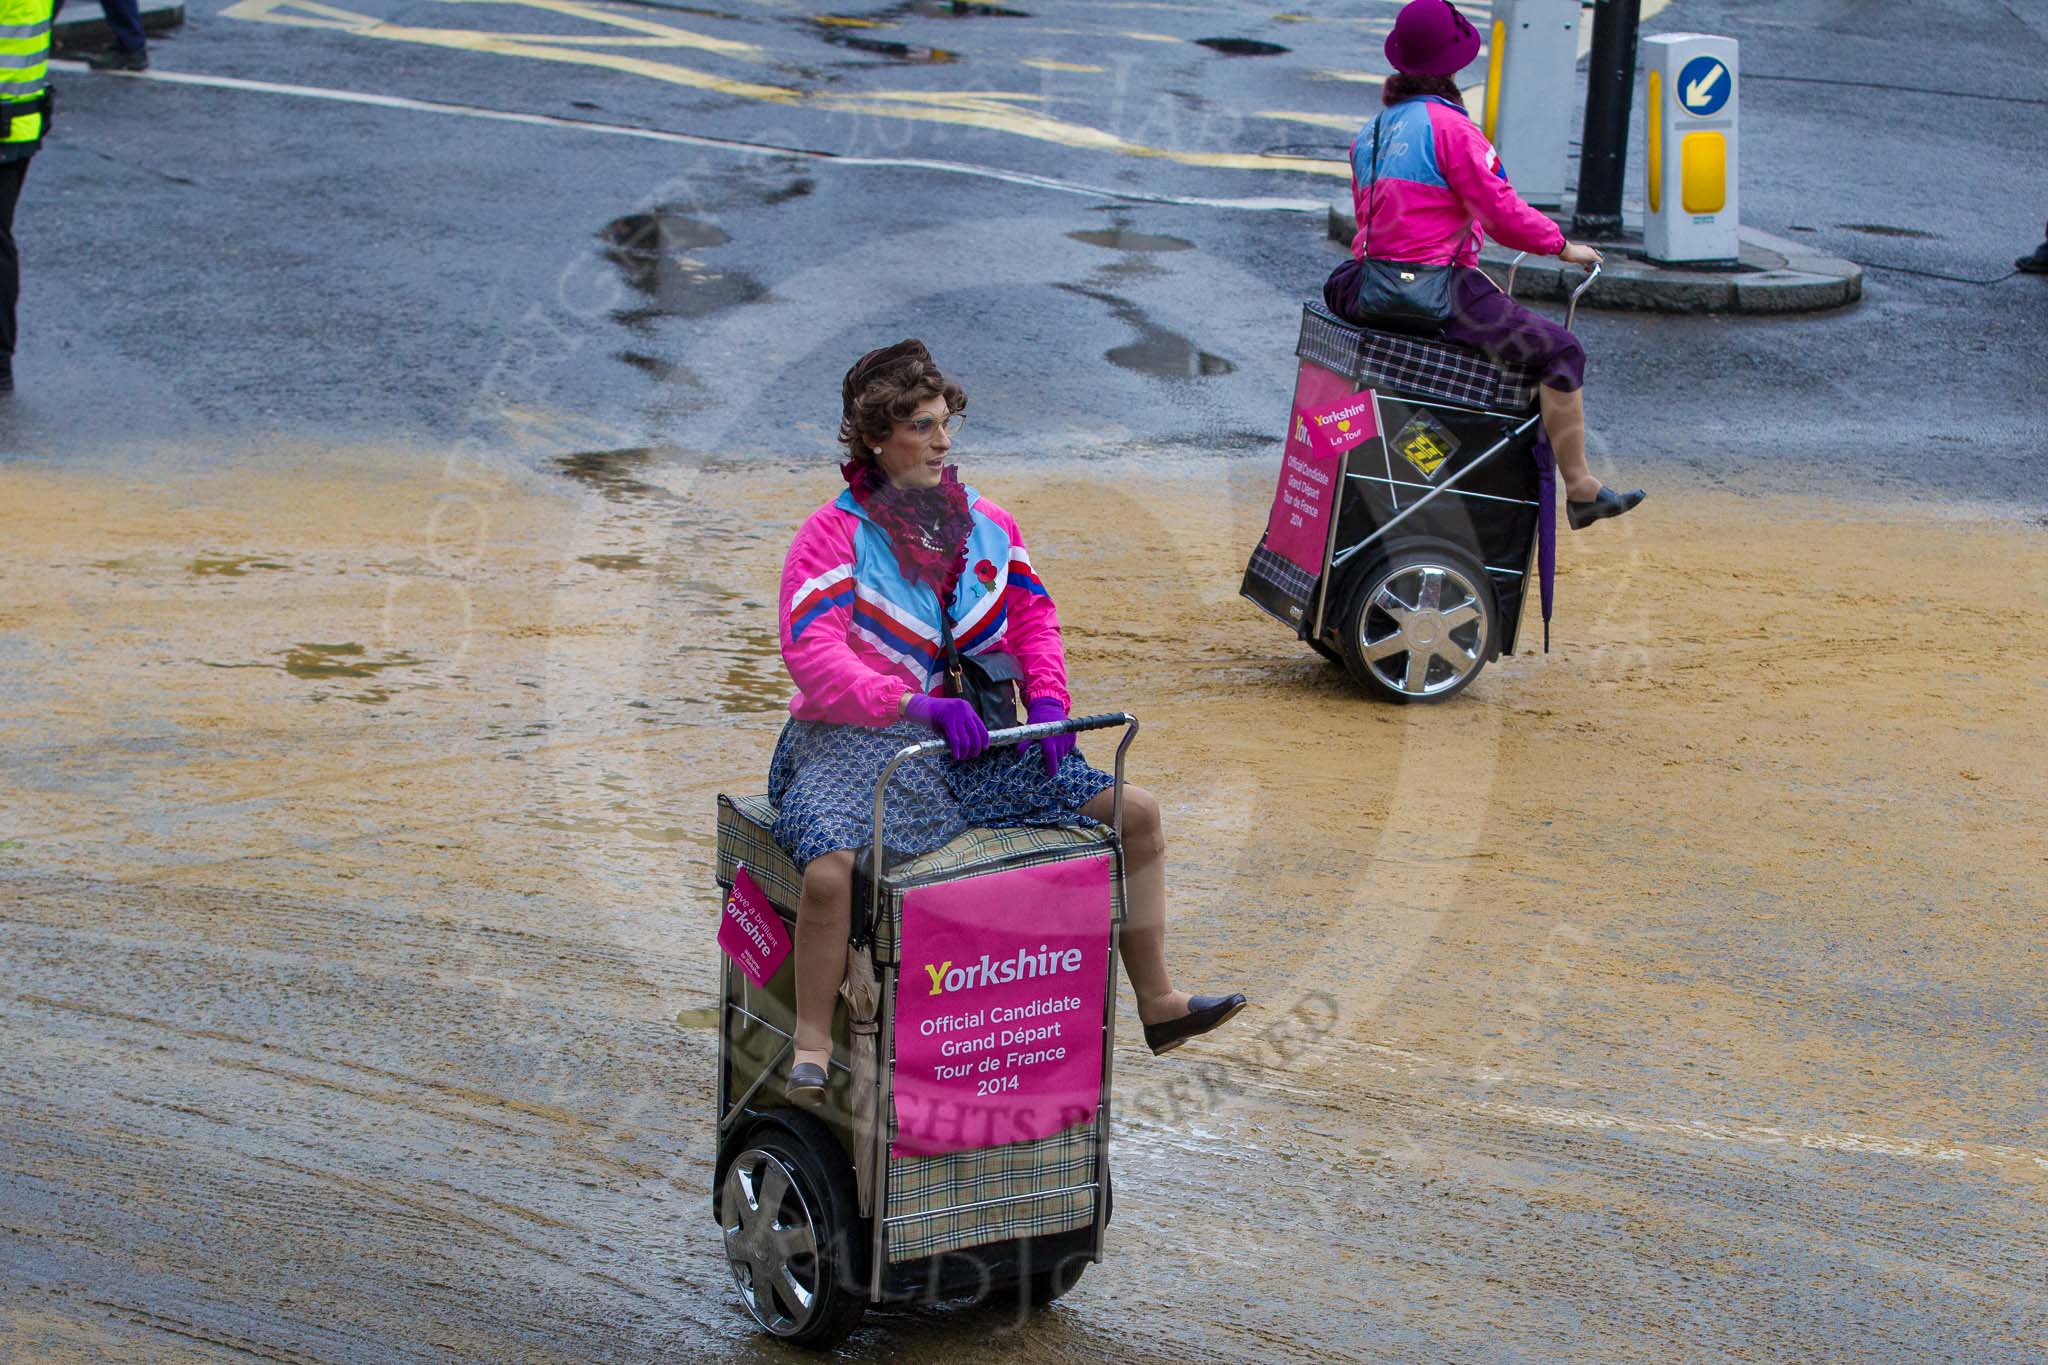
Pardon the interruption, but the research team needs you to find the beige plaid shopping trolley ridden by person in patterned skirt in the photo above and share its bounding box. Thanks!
[713,714,1137,1345]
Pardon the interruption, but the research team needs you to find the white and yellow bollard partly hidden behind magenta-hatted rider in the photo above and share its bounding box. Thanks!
[1479,0,1579,209]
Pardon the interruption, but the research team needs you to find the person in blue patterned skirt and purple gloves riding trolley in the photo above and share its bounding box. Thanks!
[768,342,1245,1107]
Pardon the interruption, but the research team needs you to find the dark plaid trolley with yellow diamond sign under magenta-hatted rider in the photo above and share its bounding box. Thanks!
[1239,303,1542,702]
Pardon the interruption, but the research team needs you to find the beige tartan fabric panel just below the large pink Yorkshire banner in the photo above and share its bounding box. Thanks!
[887,1119,1100,1263]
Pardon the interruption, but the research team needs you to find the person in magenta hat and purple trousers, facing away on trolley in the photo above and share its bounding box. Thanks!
[1323,0,1645,530]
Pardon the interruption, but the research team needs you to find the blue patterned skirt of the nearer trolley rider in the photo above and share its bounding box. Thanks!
[768,720,1116,868]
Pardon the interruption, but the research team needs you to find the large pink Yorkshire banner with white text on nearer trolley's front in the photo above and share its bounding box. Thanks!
[891,853,1112,1156]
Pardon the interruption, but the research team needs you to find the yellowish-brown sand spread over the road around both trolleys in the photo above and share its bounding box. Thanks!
[0,450,2048,1347]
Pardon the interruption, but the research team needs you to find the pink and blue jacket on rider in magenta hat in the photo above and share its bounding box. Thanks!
[1352,96,1565,266]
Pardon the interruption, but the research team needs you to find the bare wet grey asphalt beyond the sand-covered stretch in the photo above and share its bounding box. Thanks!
[6,0,2048,505]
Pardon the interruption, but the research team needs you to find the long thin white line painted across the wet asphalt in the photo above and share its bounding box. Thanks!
[49,61,1329,213]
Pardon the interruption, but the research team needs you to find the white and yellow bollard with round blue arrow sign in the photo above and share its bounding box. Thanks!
[1640,33,1741,264]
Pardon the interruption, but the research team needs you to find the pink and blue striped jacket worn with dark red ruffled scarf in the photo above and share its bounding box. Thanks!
[778,489,1071,726]
